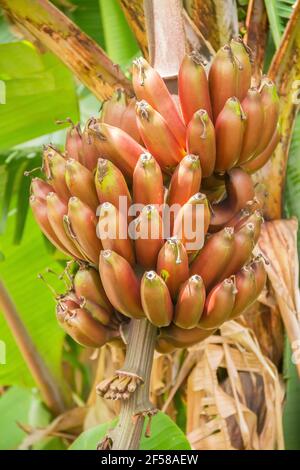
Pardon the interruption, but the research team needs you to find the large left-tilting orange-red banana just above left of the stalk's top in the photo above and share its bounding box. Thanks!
[99,250,145,318]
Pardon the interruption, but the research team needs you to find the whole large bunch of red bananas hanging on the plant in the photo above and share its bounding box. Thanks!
[30,40,272,351]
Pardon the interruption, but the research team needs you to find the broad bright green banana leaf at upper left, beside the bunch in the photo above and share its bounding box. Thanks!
[0,41,79,149]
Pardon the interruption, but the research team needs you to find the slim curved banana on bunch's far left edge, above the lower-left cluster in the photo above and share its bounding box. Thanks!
[29,195,70,256]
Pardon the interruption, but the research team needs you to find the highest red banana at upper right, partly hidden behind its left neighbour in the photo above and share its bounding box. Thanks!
[230,37,252,101]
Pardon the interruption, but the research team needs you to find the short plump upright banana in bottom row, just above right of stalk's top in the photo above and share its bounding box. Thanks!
[141,271,173,327]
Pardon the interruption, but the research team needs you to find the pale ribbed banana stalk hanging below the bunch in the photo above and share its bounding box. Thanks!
[112,319,157,450]
